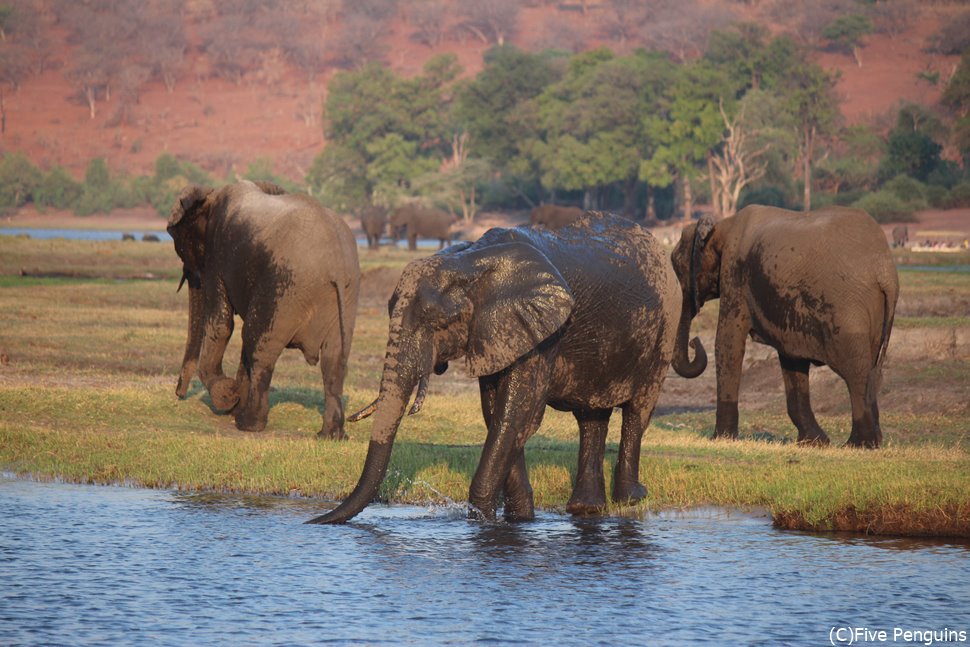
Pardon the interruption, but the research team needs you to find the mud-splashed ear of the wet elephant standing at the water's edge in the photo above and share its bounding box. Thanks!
[461,242,574,376]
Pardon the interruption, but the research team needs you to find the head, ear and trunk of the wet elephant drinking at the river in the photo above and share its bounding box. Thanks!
[310,242,573,523]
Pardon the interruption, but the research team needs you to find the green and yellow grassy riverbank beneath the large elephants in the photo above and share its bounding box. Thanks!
[0,236,970,537]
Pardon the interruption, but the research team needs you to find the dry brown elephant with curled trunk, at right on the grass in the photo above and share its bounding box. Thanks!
[672,205,899,447]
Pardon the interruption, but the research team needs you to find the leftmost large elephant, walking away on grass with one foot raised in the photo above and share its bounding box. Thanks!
[168,181,360,439]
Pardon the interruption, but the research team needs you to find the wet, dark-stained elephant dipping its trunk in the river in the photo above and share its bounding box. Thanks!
[310,212,681,523]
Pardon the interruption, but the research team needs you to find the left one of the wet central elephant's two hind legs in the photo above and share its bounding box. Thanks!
[566,409,613,515]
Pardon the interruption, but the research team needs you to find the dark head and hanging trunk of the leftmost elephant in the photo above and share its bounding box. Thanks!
[167,186,213,398]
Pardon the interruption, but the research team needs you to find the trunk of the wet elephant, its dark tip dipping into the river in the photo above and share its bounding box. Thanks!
[307,336,419,524]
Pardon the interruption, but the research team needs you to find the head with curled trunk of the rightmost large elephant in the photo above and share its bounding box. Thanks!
[671,216,721,378]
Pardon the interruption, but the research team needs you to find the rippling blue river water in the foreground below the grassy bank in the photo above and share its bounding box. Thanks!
[0,479,970,645]
